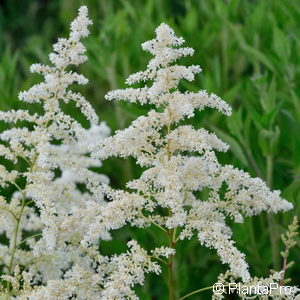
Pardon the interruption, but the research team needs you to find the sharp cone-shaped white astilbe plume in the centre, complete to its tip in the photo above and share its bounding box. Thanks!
[89,24,292,281]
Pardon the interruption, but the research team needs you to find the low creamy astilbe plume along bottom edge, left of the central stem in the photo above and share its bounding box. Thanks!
[17,241,174,300]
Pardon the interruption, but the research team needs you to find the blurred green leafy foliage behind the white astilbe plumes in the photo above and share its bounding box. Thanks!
[0,0,300,300]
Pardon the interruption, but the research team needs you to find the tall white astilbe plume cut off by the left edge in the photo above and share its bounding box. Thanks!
[0,6,113,299]
